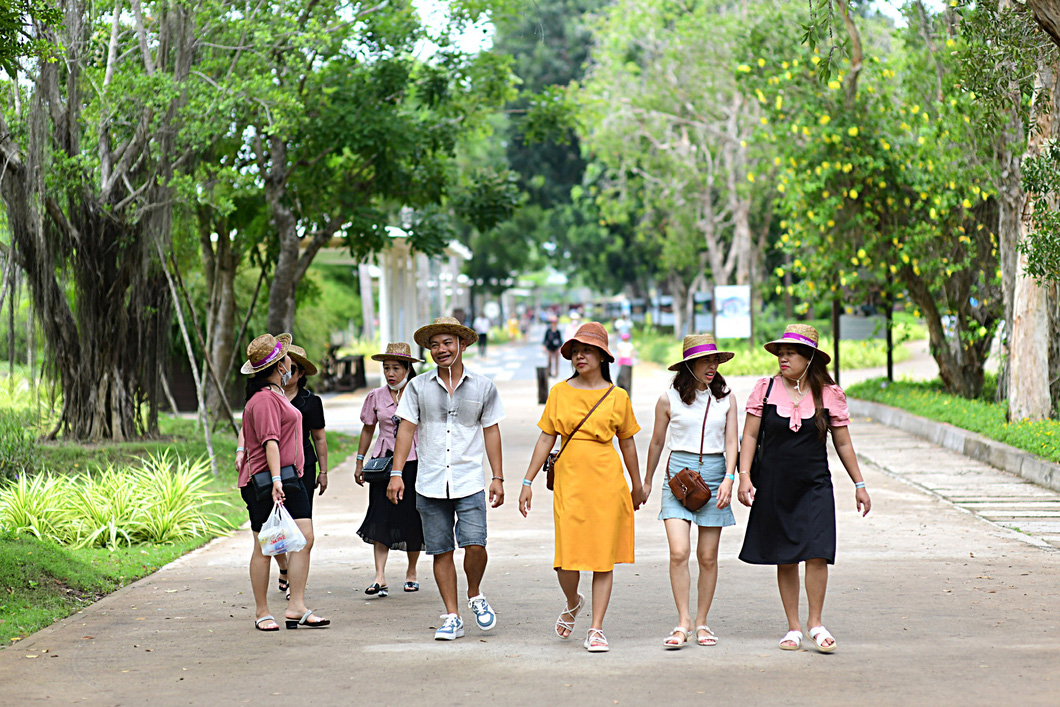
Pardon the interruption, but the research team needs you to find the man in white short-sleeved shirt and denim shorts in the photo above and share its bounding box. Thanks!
[387,317,505,640]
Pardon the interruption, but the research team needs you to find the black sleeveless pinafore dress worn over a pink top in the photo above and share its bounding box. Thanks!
[740,404,835,565]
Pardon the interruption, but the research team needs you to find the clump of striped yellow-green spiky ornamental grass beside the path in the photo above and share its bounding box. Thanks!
[0,452,232,549]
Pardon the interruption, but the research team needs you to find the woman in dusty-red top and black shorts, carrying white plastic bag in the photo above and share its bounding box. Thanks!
[237,334,331,631]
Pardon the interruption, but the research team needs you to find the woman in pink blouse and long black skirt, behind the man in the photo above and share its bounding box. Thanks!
[354,341,423,599]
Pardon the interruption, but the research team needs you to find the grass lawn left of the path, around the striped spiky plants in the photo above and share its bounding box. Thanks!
[0,416,357,646]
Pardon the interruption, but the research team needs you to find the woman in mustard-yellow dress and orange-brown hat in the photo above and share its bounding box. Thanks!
[519,321,644,653]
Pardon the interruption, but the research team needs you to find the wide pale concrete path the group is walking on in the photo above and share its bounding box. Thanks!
[0,369,1060,706]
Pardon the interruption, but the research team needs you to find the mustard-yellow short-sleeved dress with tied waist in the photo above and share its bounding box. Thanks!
[537,381,640,572]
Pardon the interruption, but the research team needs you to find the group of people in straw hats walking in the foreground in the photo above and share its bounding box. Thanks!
[240,317,870,653]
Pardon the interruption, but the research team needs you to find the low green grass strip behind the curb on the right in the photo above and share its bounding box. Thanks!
[847,378,1060,462]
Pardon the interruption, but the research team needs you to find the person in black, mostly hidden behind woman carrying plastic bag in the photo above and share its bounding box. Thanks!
[235,343,328,599]
